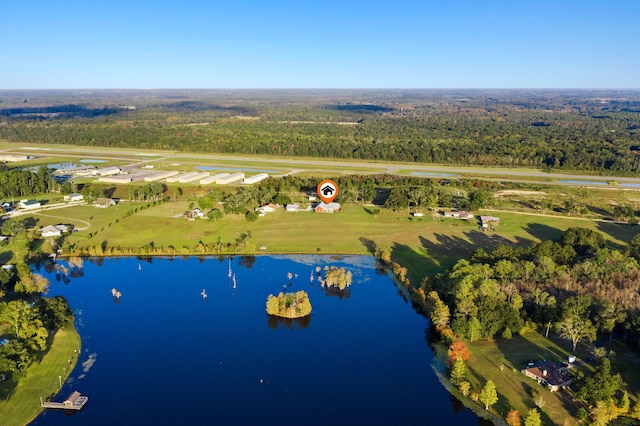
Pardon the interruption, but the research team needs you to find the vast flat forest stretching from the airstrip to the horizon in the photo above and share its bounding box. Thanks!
[0,90,640,174]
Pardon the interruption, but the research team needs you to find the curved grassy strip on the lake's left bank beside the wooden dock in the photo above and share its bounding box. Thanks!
[0,327,80,426]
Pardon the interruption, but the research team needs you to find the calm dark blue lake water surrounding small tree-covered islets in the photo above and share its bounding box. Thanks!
[34,256,478,425]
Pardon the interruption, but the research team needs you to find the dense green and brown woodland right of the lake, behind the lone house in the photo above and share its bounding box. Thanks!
[418,228,640,346]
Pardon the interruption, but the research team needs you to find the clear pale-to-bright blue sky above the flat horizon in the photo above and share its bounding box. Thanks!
[5,0,640,89]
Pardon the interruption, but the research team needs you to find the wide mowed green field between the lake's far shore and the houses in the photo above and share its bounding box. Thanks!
[48,201,640,282]
